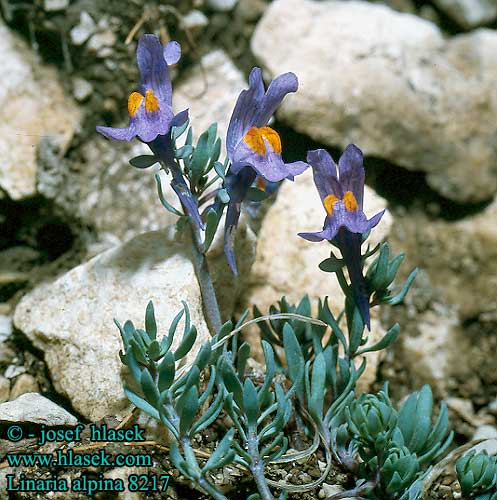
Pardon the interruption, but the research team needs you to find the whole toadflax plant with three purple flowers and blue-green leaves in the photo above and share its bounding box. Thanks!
[97,35,442,500]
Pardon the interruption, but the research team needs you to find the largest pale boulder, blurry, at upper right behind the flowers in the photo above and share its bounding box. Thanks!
[252,0,497,202]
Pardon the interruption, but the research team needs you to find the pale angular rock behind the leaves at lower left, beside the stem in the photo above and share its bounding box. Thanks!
[14,228,214,421]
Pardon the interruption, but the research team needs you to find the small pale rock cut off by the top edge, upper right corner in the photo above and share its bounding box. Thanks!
[434,0,497,29]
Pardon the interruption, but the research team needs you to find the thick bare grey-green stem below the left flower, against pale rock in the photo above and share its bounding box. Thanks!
[190,226,222,336]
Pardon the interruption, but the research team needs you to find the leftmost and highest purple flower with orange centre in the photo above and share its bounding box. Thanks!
[97,35,188,143]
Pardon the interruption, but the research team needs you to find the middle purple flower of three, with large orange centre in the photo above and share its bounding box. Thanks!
[226,68,308,182]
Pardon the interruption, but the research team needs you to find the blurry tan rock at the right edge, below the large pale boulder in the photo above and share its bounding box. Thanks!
[395,199,497,321]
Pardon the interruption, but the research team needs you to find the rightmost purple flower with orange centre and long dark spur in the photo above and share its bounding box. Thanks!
[299,144,385,329]
